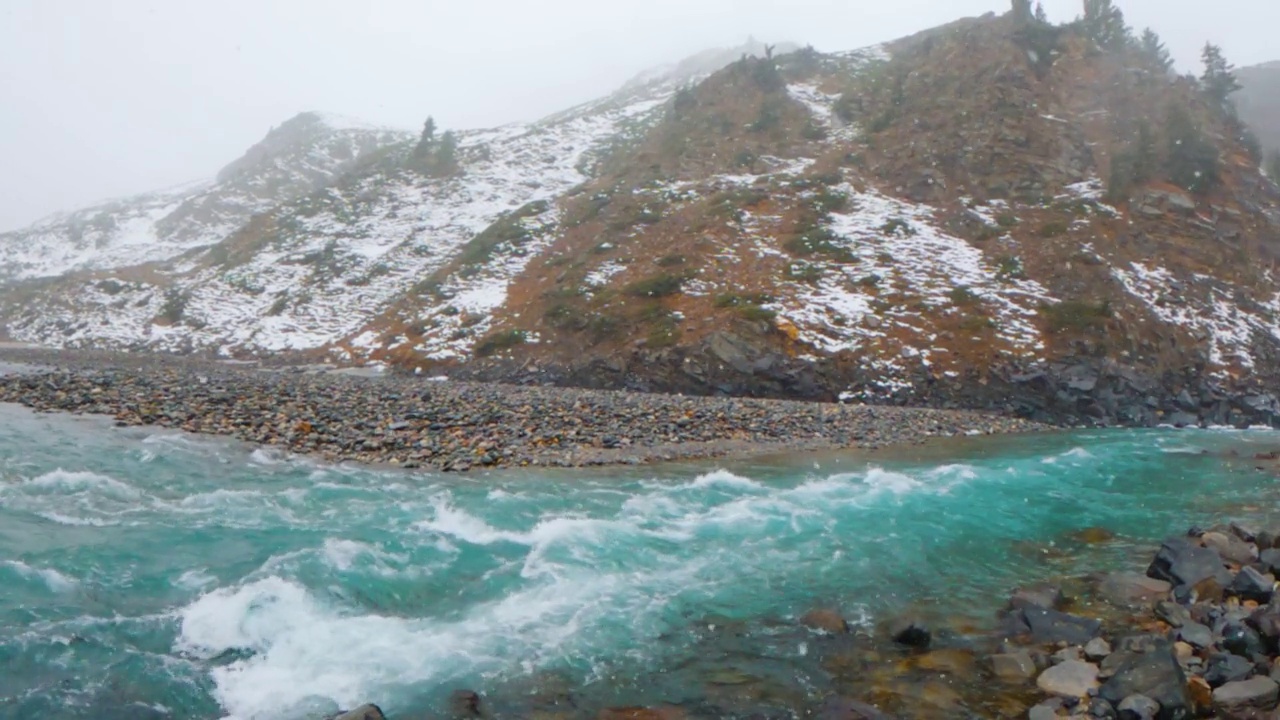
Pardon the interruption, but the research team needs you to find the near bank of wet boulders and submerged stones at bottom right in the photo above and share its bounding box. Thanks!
[317,524,1280,720]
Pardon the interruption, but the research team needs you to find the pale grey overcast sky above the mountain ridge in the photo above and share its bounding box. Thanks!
[0,0,1280,231]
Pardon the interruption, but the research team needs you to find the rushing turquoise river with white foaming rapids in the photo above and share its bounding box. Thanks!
[0,406,1280,720]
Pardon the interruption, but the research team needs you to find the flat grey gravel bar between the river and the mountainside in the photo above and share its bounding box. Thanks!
[0,348,1044,471]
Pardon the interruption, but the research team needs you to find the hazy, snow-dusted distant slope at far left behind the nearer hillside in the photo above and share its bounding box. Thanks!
[0,113,412,282]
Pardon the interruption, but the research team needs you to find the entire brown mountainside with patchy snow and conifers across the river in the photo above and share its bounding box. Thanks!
[0,9,1280,424]
